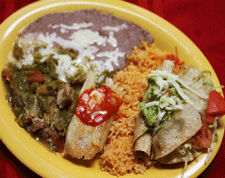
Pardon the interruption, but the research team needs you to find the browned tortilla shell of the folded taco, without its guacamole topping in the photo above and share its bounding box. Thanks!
[152,66,211,161]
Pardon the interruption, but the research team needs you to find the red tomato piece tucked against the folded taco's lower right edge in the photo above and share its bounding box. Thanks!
[192,119,211,148]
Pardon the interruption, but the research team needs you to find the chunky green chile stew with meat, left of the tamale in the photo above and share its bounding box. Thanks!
[2,43,86,151]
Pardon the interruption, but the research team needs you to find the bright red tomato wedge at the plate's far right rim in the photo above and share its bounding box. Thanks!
[206,90,225,115]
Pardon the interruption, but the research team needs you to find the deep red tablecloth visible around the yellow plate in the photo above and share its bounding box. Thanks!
[0,0,225,178]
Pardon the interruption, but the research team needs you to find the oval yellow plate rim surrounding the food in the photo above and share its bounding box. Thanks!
[0,0,224,178]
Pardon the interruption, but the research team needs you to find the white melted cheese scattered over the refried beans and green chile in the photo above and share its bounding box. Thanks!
[11,23,128,82]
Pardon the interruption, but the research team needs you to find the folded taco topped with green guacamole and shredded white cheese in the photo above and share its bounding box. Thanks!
[134,61,212,164]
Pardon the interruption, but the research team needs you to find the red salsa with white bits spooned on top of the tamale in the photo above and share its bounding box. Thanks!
[75,85,122,126]
